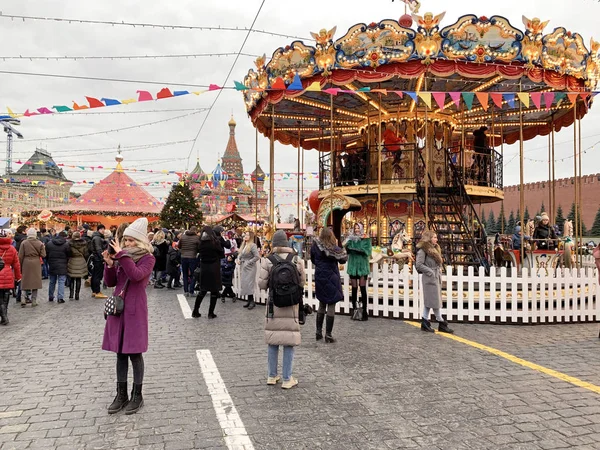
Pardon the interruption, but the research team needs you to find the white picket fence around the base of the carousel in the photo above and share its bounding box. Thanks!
[234,261,600,324]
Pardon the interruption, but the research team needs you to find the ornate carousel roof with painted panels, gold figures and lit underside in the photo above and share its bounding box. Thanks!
[243,13,600,151]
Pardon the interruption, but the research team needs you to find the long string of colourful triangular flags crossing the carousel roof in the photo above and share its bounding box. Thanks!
[0,75,600,120]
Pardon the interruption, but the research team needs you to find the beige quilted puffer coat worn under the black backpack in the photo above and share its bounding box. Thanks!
[258,247,305,346]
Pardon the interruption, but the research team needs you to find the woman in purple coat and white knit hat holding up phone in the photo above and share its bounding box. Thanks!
[102,218,155,414]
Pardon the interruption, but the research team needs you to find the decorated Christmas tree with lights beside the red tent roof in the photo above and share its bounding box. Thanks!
[160,182,202,229]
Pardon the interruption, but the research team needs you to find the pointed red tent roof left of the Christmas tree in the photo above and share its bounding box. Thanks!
[67,168,162,215]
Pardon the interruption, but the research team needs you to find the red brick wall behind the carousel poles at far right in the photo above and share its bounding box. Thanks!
[488,173,600,230]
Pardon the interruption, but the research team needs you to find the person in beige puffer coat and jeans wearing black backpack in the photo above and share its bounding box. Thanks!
[258,230,304,389]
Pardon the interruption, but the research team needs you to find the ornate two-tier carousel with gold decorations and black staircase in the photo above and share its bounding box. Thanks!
[243,10,600,267]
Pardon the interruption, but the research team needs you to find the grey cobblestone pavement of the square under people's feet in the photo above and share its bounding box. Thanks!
[0,289,600,450]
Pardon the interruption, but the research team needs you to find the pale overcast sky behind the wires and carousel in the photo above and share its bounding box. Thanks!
[0,0,600,216]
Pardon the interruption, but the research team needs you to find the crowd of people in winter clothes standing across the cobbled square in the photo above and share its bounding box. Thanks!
[0,218,600,414]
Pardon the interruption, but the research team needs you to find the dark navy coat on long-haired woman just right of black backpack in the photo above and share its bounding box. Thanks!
[310,239,348,304]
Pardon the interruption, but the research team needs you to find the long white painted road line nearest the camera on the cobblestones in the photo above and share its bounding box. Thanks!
[196,350,254,450]
